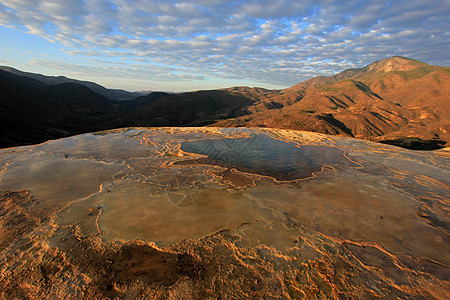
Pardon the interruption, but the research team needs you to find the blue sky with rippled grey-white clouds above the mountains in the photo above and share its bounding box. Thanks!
[0,0,450,92]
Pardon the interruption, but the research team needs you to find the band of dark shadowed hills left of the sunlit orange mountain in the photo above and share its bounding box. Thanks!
[0,70,253,147]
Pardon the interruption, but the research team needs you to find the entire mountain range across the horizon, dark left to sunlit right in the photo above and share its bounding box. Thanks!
[0,56,450,149]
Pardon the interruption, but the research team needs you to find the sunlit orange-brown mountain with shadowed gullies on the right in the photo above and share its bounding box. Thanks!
[215,56,450,149]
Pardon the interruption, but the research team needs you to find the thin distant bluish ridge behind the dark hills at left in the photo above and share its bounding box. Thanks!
[0,66,148,101]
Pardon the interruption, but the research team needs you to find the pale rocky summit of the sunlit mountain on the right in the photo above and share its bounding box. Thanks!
[363,56,427,73]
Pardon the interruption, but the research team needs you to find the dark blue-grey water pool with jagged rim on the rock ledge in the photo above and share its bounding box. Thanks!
[179,134,359,181]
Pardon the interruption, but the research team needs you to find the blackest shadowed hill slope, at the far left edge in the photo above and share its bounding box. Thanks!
[0,70,115,147]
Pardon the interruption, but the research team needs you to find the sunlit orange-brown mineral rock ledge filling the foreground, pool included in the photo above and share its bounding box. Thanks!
[0,127,450,299]
